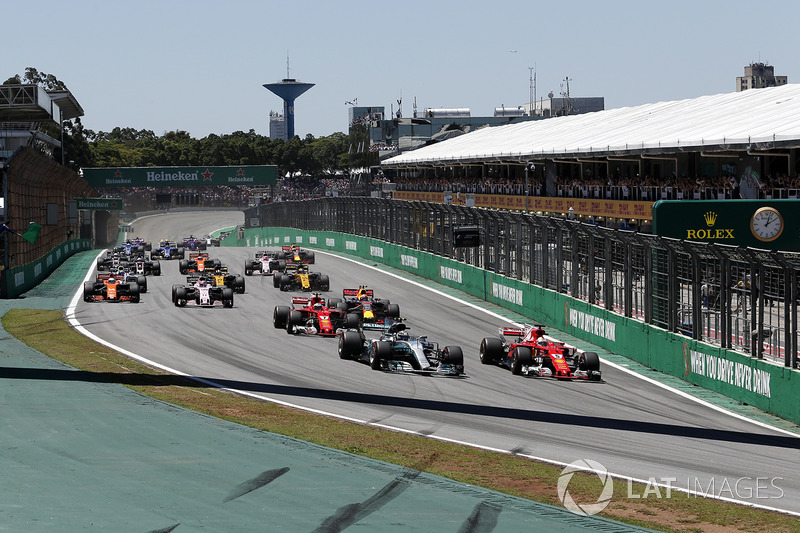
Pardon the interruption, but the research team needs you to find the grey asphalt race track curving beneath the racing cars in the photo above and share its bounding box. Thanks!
[75,211,800,513]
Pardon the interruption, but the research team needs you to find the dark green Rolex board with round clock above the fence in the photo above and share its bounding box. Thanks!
[653,200,800,251]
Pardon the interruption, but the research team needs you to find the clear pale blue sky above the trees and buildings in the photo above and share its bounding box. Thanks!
[7,0,800,138]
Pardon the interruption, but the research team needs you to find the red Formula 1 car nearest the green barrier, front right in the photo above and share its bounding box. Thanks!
[480,325,602,381]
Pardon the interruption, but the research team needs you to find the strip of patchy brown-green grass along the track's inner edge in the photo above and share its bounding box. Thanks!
[2,309,800,533]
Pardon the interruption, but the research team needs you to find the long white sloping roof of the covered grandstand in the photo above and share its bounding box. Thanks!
[381,84,800,167]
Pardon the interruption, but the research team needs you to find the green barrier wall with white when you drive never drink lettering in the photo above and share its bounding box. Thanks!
[227,227,800,423]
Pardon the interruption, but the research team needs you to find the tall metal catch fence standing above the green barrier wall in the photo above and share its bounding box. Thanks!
[252,197,800,368]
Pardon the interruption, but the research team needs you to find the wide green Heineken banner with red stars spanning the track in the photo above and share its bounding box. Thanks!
[83,165,278,187]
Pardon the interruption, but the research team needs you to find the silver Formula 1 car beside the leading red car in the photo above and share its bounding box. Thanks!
[339,321,466,377]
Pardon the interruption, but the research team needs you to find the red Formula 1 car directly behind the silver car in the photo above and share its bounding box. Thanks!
[272,294,358,337]
